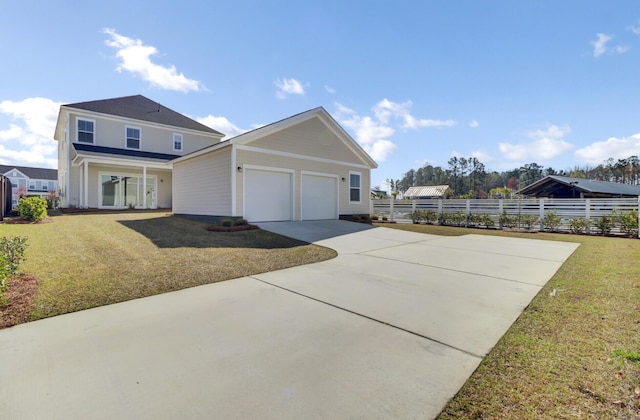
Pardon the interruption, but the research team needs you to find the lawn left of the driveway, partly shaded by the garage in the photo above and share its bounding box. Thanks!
[0,212,336,320]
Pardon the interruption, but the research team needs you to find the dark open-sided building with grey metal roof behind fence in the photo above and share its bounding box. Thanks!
[517,175,640,198]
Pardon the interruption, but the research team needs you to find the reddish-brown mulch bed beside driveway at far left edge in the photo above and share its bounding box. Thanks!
[0,274,38,328]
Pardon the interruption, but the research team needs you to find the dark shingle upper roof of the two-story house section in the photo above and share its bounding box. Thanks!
[64,95,224,136]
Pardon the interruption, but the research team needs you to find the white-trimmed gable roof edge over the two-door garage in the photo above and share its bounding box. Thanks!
[175,106,378,168]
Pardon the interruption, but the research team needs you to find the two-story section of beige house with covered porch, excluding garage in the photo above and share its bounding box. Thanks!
[54,95,224,209]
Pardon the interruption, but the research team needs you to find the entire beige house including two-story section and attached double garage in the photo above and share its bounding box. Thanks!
[54,95,377,221]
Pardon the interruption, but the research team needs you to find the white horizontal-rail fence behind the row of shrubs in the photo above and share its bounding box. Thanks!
[371,197,640,237]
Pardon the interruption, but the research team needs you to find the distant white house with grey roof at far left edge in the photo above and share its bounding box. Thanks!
[0,165,58,207]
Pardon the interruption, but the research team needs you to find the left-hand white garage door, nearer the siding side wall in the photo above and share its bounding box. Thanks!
[244,169,293,222]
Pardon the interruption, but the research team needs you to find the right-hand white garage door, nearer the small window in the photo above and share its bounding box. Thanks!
[301,174,338,220]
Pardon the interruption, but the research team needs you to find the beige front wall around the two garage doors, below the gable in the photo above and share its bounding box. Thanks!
[235,150,371,220]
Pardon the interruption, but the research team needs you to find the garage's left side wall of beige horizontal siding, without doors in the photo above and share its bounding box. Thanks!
[173,148,232,216]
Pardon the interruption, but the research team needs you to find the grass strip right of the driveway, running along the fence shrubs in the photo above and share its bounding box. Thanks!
[383,224,640,419]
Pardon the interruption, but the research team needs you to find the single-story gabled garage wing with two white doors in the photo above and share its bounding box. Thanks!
[171,107,377,221]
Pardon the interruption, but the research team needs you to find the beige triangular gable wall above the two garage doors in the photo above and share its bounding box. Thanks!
[250,118,361,164]
